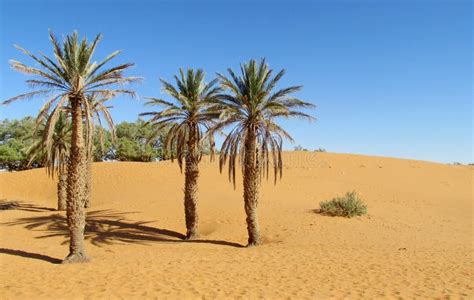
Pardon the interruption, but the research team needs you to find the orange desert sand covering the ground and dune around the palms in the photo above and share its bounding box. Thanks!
[0,152,474,299]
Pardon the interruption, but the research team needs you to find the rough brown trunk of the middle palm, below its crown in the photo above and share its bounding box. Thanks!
[184,126,199,239]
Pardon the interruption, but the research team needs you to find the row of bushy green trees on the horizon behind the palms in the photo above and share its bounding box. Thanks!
[0,117,170,171]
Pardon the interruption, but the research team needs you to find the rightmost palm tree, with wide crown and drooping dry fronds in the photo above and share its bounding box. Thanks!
[215,59,314,246]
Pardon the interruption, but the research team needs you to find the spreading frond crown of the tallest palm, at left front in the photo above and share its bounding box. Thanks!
[3,32,140,152]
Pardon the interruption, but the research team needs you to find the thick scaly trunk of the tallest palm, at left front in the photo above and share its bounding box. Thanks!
[63,98,89,263]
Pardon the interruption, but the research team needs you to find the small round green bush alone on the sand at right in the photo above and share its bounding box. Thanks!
[319,192,367,218]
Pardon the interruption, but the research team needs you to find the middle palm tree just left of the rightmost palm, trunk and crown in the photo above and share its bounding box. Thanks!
[141,69,221,239]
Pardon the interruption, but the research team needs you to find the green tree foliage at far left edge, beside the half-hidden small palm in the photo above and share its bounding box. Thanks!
[0,117,40,171]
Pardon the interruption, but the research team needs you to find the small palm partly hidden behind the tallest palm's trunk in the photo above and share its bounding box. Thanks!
[27,112,71,210]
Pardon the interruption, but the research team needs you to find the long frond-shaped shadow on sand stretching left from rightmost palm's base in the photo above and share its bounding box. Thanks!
[3,210,244,248]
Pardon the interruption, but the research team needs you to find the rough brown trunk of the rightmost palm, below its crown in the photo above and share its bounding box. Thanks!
[244,126,260,246]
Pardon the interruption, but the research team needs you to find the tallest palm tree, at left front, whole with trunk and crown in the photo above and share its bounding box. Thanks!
[3,32,139,263]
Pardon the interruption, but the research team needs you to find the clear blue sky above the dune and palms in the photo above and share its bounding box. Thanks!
[0,0,473,163]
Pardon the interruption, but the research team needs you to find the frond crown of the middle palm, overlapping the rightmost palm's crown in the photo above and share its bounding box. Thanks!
[141,69,221,168]
